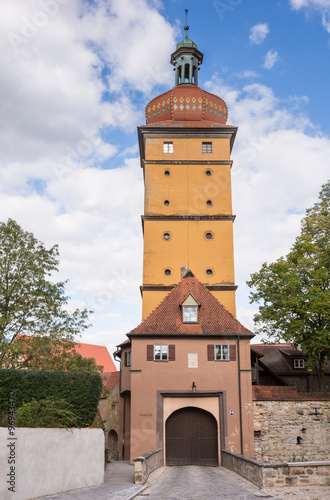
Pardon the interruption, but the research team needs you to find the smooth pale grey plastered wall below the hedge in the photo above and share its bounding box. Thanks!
[0,427,104,500]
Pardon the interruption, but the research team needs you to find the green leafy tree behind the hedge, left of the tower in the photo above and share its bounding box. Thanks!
[0,219,99,371]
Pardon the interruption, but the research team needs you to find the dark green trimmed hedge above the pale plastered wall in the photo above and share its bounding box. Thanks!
[0,369,102,427]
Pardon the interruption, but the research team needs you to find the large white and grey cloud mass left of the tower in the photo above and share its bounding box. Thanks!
[0,0,175,360]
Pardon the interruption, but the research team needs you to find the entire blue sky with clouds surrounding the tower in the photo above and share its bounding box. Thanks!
[0,0,330,368]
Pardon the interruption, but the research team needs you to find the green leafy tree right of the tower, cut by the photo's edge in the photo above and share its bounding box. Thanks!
[247,181,330,390]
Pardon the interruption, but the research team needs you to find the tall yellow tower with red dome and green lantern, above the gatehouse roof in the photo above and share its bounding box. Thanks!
[138,26,237,319]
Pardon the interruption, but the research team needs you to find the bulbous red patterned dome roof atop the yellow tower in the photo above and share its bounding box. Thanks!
[146,84,228,125]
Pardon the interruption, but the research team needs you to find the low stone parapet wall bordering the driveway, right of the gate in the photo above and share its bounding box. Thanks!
[221,450,330,488]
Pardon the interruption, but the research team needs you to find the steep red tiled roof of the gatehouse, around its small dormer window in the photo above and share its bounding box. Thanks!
[128,277,254,336]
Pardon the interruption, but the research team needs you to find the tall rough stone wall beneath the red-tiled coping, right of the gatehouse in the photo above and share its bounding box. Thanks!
[253,401,330,463]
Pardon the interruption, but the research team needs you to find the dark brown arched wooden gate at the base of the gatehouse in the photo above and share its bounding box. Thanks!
[165,406,218,466]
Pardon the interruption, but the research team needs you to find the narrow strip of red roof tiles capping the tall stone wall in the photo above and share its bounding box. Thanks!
[252,385,330,401]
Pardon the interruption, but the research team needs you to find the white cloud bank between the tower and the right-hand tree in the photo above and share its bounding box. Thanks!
[206,79,330,328]
